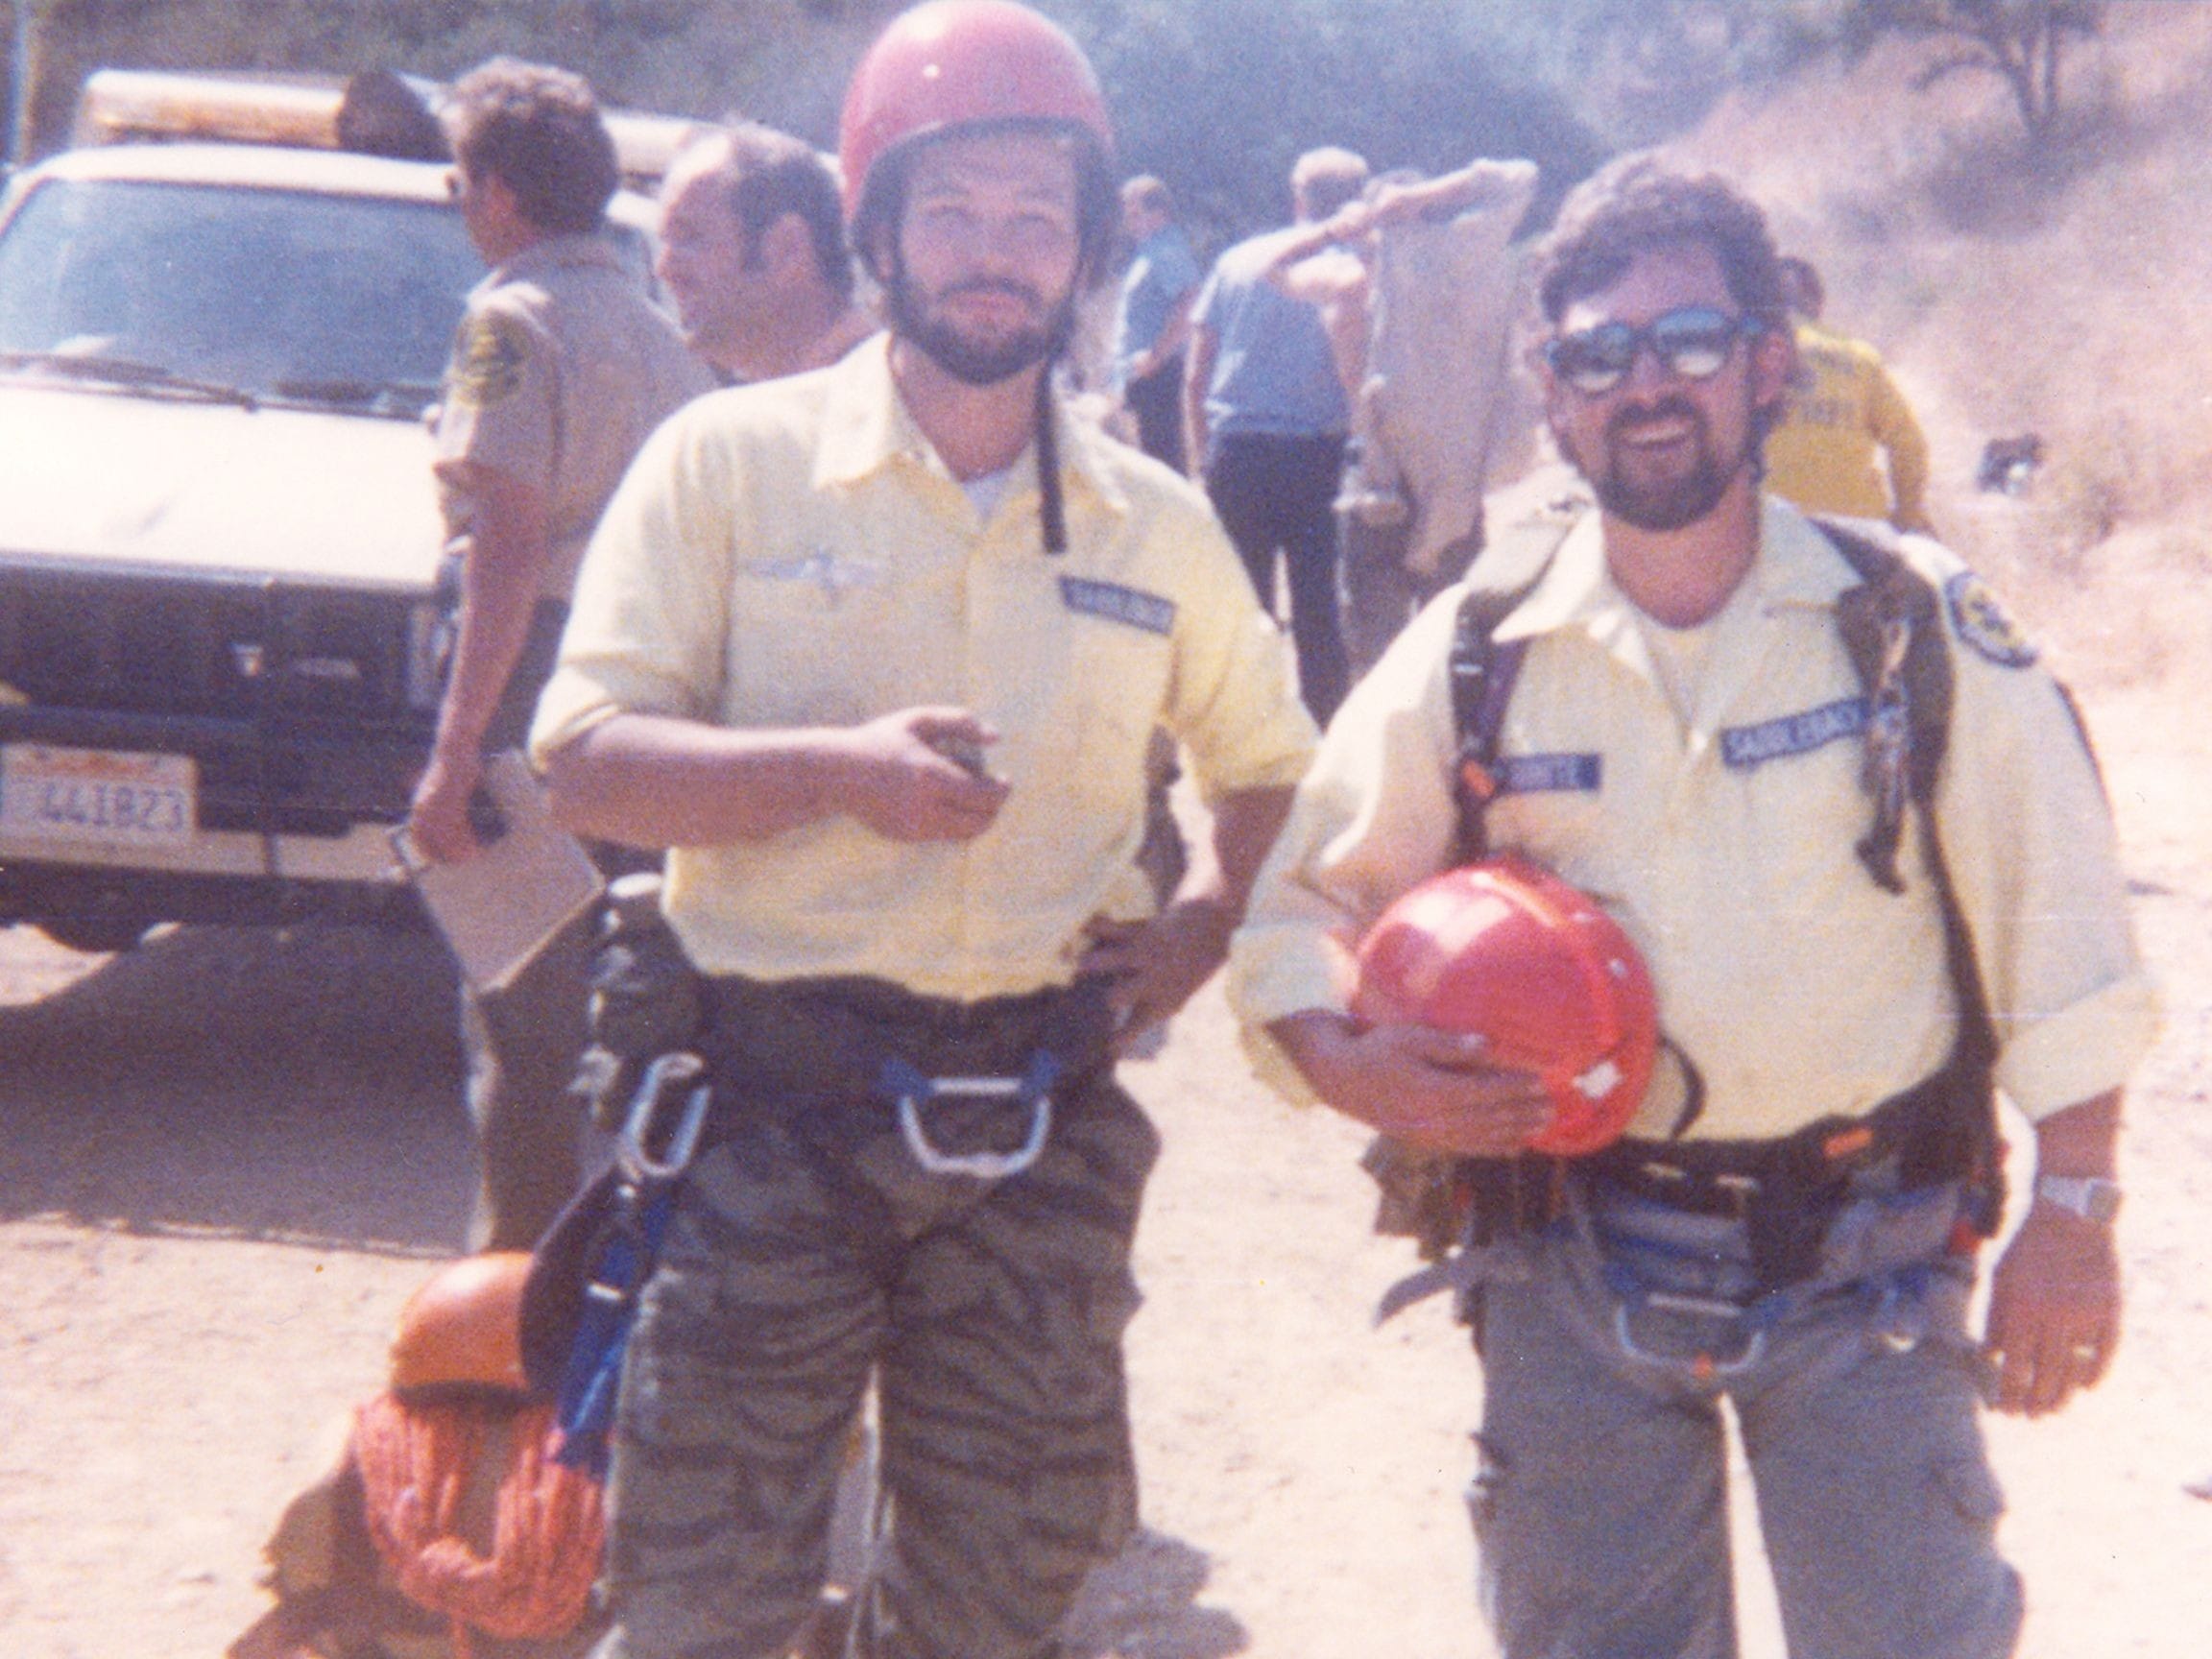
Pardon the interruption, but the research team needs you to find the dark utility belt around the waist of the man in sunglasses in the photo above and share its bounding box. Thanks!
[1464,1060,2002,1289]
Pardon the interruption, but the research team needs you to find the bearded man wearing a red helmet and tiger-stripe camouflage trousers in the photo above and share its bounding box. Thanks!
[536,0,1314,1659]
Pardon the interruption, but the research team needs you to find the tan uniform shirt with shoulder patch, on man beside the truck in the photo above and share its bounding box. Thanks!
[434,237,712,599]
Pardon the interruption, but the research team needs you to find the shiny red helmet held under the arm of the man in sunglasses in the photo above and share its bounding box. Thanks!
[1352,858,1659,1157]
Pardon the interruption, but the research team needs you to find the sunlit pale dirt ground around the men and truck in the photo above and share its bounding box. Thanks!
[0,667,2212,1659]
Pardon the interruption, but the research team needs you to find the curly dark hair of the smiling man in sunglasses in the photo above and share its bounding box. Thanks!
[1535,153,1788,327]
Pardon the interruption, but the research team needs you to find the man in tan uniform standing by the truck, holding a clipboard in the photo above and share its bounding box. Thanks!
[407,58,708,1250]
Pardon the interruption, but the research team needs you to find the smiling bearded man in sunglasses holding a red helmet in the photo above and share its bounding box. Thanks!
[1232,157,2156,1659]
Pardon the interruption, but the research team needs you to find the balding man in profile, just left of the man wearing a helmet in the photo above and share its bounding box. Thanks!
[655,122,874,385]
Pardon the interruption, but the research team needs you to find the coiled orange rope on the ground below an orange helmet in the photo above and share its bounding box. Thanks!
[354,1394,606,1659]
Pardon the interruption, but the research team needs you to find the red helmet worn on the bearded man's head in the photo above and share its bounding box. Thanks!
[836,0,1113,256]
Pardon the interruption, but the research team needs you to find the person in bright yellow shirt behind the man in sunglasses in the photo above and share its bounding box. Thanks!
[1766,259,1934,533]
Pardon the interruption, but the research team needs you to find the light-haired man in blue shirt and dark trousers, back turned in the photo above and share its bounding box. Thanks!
[1184,146,1367,723]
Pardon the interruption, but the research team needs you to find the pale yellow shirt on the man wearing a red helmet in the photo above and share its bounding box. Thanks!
[533,339,1314,999]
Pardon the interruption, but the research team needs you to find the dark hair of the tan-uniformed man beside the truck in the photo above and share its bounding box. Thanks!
[445,58,621,232]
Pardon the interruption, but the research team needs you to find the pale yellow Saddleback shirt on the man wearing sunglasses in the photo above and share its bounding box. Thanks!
[1230,497,2156,1140]
